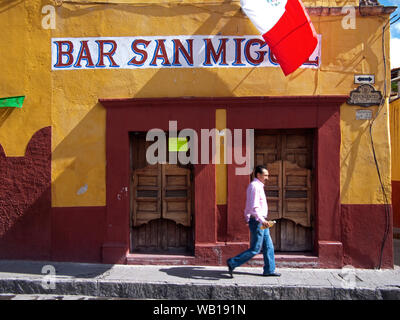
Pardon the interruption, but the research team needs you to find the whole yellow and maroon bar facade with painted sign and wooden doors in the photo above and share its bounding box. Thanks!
[0,0,394,268]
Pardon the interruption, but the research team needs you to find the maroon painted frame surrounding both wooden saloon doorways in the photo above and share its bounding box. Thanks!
[99,96,347,267]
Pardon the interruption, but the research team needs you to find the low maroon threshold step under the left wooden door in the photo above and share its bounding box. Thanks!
[126,253,195,265]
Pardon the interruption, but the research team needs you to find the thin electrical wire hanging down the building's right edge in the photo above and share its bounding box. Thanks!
[369,15,399,270]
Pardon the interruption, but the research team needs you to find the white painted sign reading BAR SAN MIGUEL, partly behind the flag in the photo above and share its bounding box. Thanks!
[51,35,321,70]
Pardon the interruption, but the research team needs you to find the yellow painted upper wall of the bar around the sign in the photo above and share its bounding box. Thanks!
[0,0,391,207]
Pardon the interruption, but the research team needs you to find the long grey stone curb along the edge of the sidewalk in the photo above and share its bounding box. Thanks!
[0,278,400,300]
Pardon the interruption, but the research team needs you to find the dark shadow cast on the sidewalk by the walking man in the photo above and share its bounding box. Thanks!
[160,267,260,280]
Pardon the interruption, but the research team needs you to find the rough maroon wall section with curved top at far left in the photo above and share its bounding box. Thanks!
[0,127,51,259]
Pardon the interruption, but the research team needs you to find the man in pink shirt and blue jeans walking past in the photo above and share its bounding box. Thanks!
[226,166,280,277]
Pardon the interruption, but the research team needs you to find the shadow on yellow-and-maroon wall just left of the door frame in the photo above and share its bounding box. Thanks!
[52,103,106,262]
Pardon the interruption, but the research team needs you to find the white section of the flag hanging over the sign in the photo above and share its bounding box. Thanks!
[240,0,287,35]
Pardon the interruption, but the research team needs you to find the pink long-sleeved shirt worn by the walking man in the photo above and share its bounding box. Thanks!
[244,178,268,223]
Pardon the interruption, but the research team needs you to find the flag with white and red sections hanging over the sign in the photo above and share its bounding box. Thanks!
[240,0,318,76]
